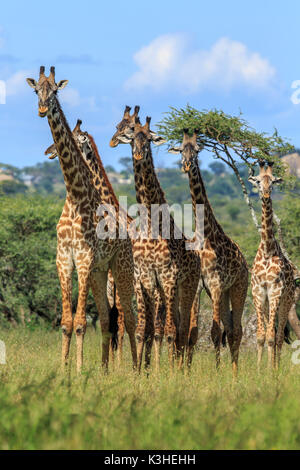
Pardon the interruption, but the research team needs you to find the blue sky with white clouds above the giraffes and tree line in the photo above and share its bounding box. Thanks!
[0,0,300,168]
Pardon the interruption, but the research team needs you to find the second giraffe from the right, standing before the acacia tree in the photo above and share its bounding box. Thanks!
[169,129,248,375]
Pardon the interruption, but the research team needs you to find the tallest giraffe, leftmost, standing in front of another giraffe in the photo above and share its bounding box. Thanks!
[27,66,136,372]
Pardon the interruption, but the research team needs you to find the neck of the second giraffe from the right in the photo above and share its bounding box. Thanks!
[188,161,224,240]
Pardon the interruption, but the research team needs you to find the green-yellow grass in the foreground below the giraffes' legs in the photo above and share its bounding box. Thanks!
[0,328,300,450]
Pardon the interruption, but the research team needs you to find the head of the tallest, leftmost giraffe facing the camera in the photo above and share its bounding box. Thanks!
[26,66,68,117]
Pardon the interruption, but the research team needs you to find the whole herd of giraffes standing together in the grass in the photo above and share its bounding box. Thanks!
[27,66,295,375]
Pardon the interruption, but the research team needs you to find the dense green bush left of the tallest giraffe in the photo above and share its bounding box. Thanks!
[0,197,62,322]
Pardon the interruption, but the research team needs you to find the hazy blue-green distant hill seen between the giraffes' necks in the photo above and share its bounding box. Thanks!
[0,158,276,204]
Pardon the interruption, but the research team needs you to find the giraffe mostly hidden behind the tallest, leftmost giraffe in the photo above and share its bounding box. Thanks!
[45,119,164,368]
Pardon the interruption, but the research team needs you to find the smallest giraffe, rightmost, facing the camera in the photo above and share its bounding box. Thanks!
[249,161,295,368]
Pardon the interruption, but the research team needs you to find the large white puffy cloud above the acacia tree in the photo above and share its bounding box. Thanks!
[125,34,276,93]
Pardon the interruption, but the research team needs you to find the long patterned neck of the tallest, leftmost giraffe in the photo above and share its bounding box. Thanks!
[48,98,92,203]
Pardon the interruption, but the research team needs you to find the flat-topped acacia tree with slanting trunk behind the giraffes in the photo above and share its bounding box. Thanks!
[157,105,300,338]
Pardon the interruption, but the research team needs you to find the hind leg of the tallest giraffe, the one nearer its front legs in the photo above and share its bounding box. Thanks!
[90,270,111,370]
